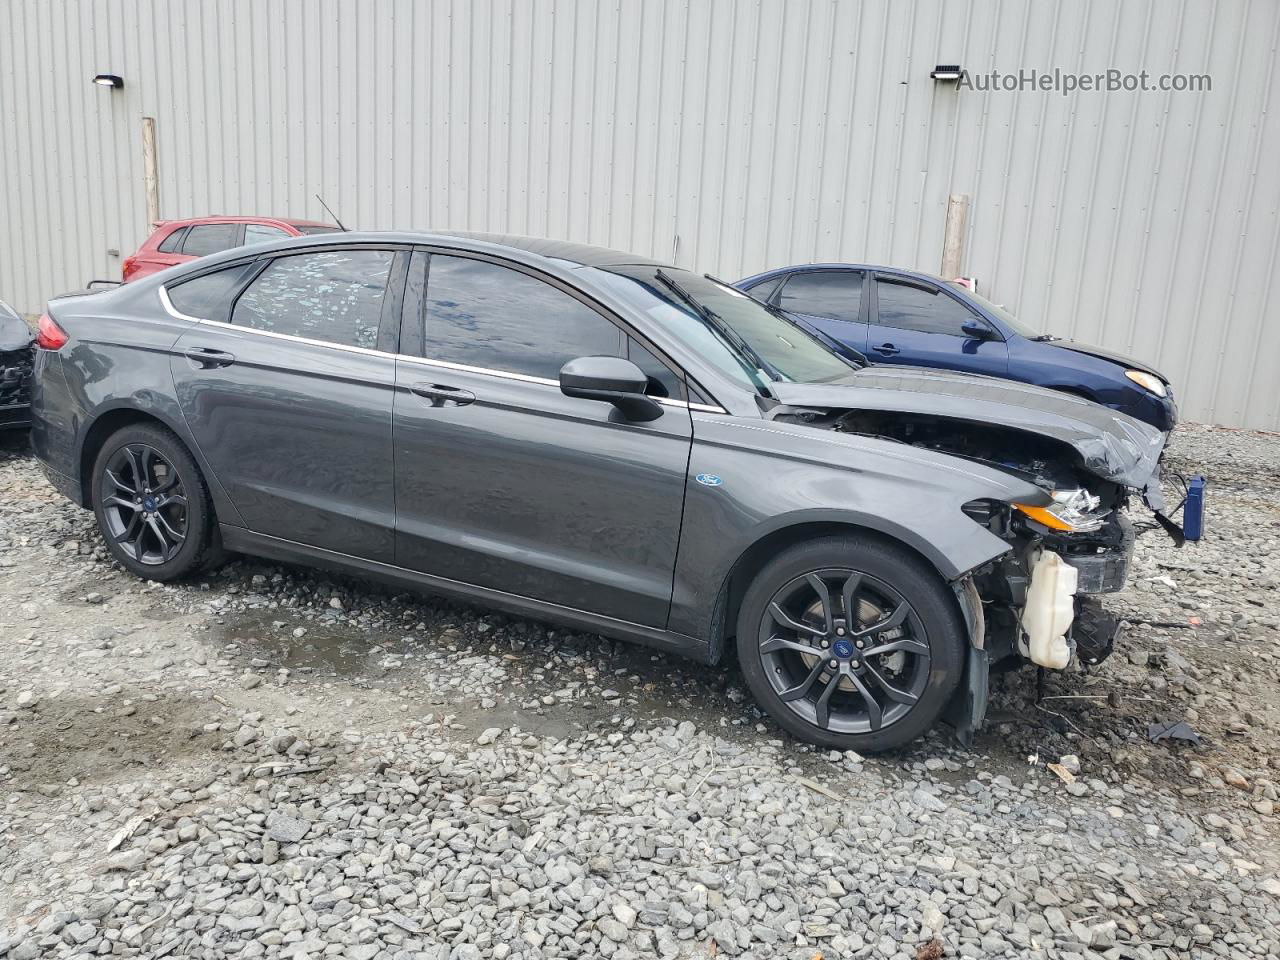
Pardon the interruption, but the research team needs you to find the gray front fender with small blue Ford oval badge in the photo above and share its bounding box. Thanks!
[669,415,1047,647]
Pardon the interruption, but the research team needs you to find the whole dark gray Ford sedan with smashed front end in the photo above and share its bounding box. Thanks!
[32,233,1176,750]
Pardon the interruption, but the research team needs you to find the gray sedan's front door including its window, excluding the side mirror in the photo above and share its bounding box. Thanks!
[394,252,692,627]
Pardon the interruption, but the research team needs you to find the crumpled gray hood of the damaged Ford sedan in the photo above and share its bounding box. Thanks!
[772,366,1165,499]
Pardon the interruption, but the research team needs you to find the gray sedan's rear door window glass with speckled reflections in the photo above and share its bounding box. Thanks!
[232,250,396,349]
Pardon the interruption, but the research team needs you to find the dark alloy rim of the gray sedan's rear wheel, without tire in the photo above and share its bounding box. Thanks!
[102,443,187,566]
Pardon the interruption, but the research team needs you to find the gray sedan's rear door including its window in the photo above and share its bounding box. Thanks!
[166,246,408,562]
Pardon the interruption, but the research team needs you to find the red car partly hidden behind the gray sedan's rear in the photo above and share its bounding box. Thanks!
[122,216,338,283]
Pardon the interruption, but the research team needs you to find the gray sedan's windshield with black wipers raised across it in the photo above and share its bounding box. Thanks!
[584,265,856,392]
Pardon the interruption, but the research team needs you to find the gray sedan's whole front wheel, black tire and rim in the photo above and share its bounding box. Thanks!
[737,536,965,753]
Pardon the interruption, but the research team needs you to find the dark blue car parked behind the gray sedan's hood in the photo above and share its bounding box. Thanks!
[735,264,1178,433]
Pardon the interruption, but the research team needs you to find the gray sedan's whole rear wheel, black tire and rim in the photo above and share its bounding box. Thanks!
[91,424,218,582]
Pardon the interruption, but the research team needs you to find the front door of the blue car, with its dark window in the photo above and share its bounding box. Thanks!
[867,274,1009,376]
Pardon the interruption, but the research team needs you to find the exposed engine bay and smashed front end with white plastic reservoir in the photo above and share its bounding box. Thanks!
[777,408,1180,739]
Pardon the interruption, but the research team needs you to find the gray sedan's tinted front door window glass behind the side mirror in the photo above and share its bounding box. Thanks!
[424,255,622,380]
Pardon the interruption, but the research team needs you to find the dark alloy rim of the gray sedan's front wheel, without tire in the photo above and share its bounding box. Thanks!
[759,568,931,733]
